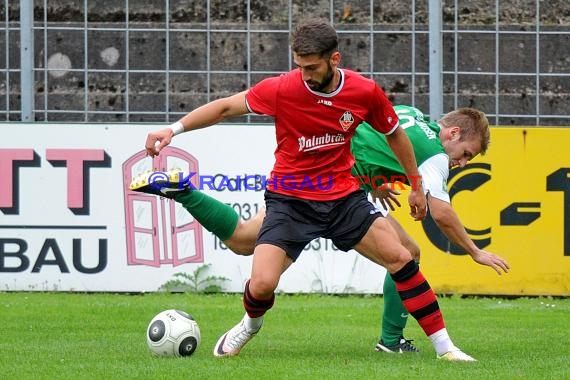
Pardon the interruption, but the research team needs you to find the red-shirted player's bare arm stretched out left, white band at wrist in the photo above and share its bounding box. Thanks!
[145,91,249,157]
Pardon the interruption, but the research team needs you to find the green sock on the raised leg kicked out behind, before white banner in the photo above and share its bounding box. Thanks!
[172,190,239,241]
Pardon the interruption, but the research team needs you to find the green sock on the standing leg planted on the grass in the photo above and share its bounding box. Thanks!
[380,272,408,346]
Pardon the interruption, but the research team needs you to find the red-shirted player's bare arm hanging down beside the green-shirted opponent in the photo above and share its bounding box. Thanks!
[386,128,427,220]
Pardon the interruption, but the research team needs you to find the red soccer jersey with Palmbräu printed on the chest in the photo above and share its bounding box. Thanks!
[246,69,398,201]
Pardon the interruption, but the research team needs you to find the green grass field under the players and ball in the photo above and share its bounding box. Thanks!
[0,292,570,380]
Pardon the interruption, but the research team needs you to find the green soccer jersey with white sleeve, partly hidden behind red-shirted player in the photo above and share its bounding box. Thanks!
[351,106,449,202]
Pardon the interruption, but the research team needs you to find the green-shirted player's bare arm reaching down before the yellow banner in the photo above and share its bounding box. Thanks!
[428,196,510,274]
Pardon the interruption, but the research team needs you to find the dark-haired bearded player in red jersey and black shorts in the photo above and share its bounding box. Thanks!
[139,20,475,361]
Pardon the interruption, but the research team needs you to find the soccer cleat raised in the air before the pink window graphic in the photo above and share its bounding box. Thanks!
[129,169,191,199]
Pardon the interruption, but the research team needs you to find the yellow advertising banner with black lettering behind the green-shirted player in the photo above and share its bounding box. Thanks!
[394,127,570,296]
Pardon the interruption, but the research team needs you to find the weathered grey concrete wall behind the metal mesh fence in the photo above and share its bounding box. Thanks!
[0,0,570,125]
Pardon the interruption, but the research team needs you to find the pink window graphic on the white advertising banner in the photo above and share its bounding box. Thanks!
[123,147,204,267]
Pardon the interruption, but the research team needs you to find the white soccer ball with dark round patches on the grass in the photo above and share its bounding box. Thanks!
[146,309,201,357]
